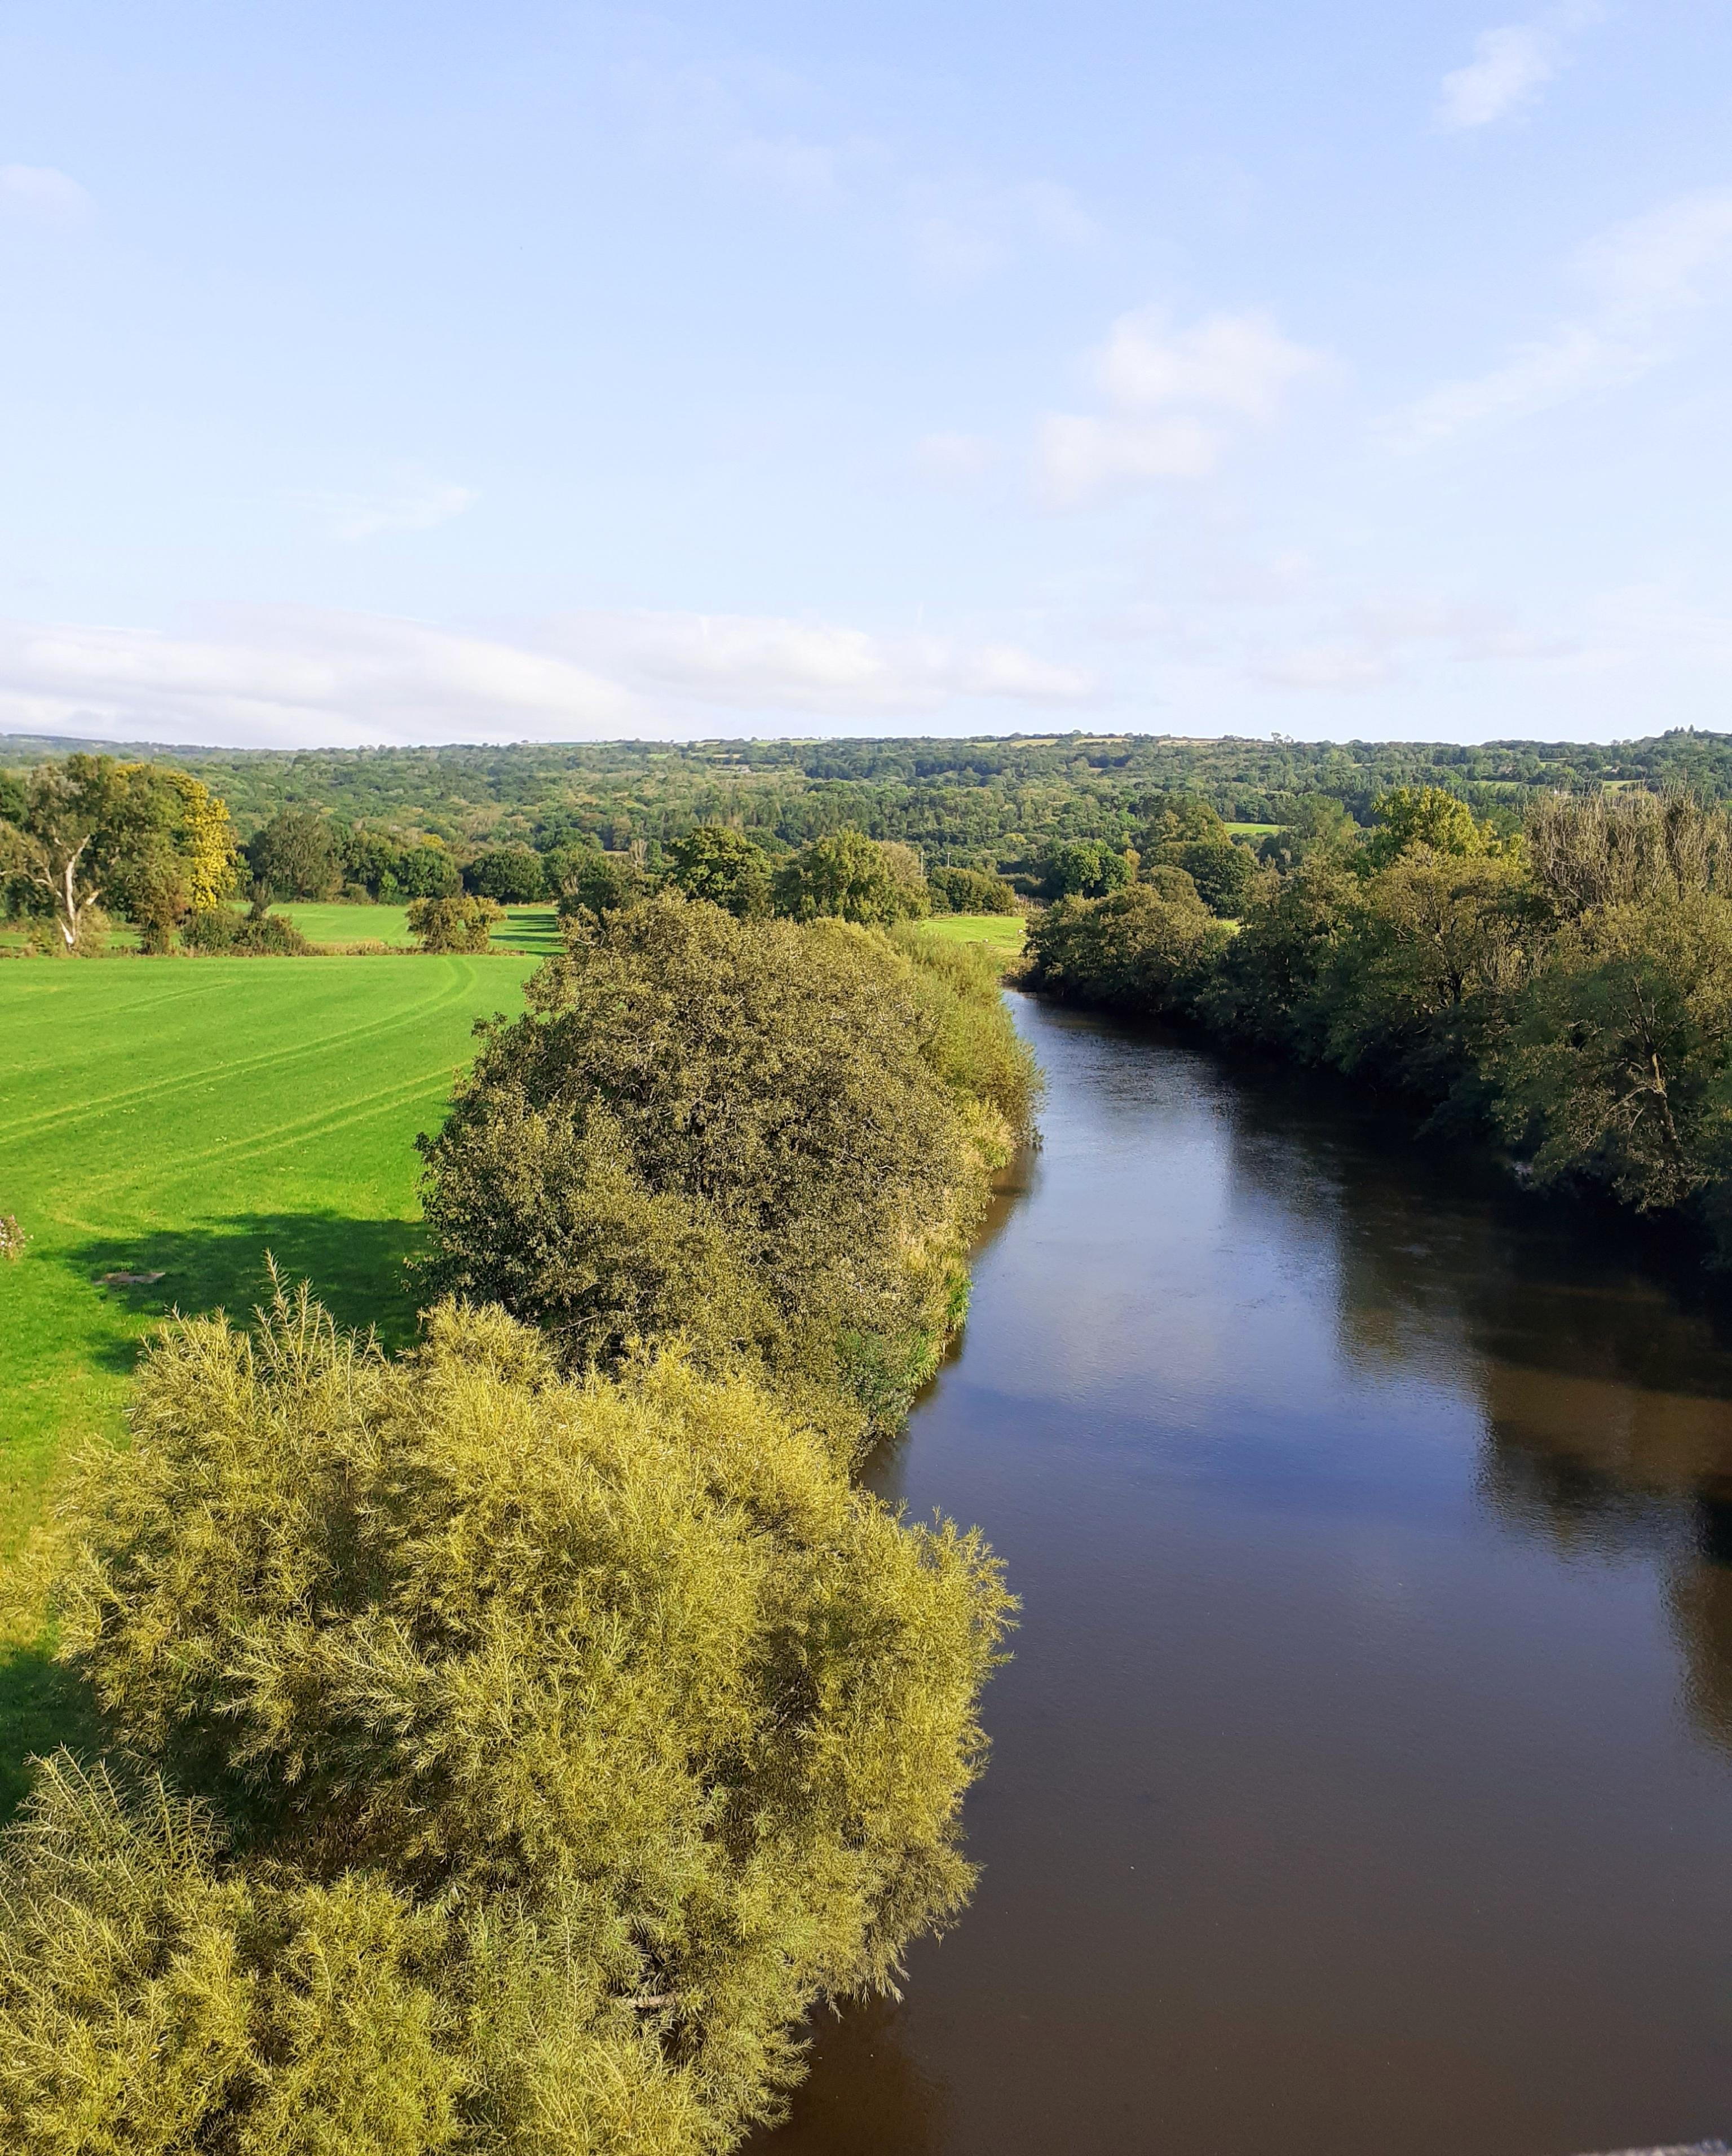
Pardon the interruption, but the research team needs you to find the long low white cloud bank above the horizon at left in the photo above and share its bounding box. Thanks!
[0,608,1092,746]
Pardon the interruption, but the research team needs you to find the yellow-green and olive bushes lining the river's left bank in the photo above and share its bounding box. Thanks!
[0,891,1033,2156]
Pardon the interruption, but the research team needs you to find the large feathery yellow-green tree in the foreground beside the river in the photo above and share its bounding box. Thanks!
[0,1296,1009,2156]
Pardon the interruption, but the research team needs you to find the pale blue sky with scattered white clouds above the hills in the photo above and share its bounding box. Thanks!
[0,0,1732,746]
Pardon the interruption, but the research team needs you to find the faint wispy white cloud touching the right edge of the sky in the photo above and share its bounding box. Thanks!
[1382,188,1732,449]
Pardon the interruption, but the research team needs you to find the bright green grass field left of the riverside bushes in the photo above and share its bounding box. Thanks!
[0,953,531,1809]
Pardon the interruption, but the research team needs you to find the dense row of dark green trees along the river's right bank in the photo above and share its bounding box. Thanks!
[1027,789,1732,1249]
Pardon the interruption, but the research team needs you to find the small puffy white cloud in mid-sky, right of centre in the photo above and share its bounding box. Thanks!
[1035,308,1324,509]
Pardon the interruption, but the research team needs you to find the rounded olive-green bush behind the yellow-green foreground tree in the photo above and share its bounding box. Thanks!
[421,893,1027,1421]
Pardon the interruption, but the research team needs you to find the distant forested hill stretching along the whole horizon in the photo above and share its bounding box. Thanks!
[0,729,1732,858]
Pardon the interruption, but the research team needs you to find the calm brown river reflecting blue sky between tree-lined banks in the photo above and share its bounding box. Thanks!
[755,1004,1732,2156]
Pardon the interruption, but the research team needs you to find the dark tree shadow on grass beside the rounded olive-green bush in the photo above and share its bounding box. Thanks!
[65,1214,423,1371]
